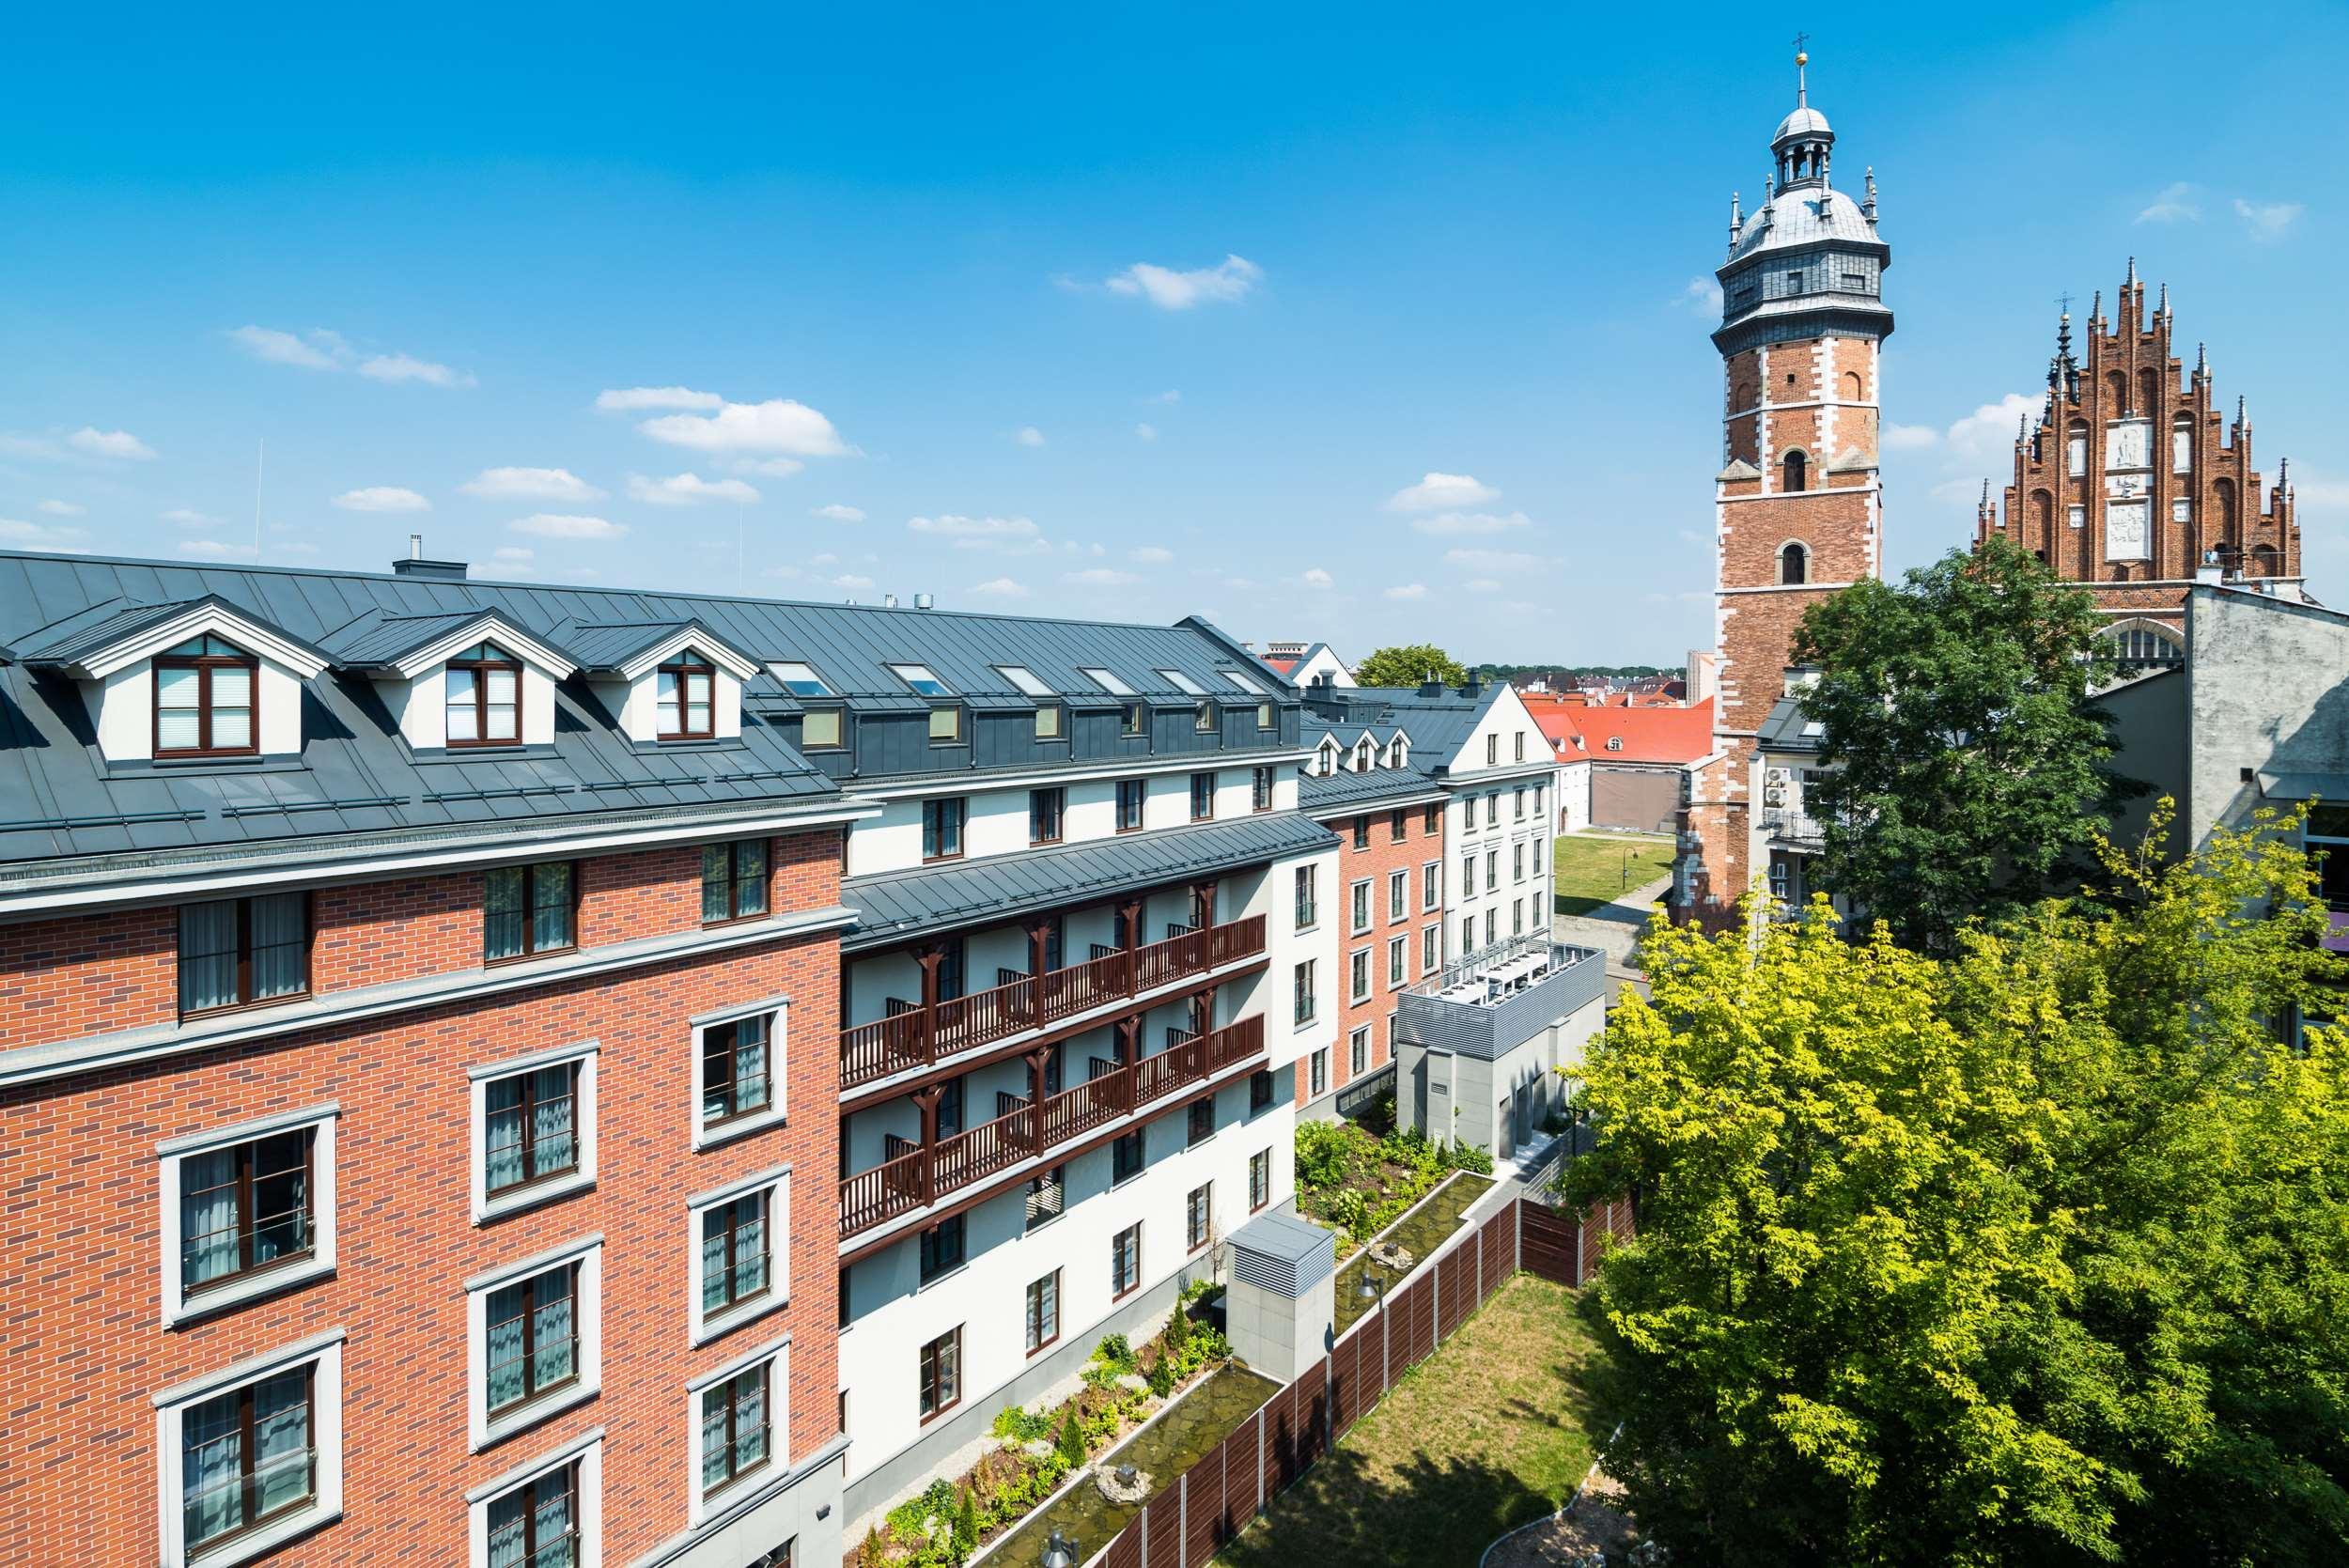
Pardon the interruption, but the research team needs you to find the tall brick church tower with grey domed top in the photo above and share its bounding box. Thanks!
[1672,56,1893,924]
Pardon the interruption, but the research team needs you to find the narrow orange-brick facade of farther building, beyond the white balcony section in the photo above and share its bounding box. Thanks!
[1297,805,1456,1106]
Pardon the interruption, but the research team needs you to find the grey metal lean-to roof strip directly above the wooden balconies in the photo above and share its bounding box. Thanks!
[841,812,1337,948]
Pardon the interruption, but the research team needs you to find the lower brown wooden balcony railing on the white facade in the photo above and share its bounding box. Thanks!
[841,1014,1264,1239]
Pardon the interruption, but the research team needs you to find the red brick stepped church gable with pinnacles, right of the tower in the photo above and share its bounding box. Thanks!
[1976,258,2300,629]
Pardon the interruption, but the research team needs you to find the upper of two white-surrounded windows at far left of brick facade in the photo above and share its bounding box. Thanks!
[179,1126,318,1298]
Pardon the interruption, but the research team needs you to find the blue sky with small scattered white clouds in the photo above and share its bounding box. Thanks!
[0,5,2349,662]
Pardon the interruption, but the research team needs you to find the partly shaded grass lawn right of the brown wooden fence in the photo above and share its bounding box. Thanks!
[1217,1275,1602,1568]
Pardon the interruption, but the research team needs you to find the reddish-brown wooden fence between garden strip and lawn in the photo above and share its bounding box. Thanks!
[1093,1197,1630,1568]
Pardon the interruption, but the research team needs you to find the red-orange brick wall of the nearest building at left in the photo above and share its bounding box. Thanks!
[0,831,841,1568]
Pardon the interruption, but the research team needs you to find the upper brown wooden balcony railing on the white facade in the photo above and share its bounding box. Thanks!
[841,915,1264,1089]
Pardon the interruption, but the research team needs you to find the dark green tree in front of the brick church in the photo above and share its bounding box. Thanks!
[1795,540,2140,953]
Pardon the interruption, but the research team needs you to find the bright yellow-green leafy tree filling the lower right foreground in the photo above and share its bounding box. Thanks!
[1569,824,2349,1566]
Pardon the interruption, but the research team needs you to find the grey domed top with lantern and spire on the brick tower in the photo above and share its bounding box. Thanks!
[1713,54,1893,354]
